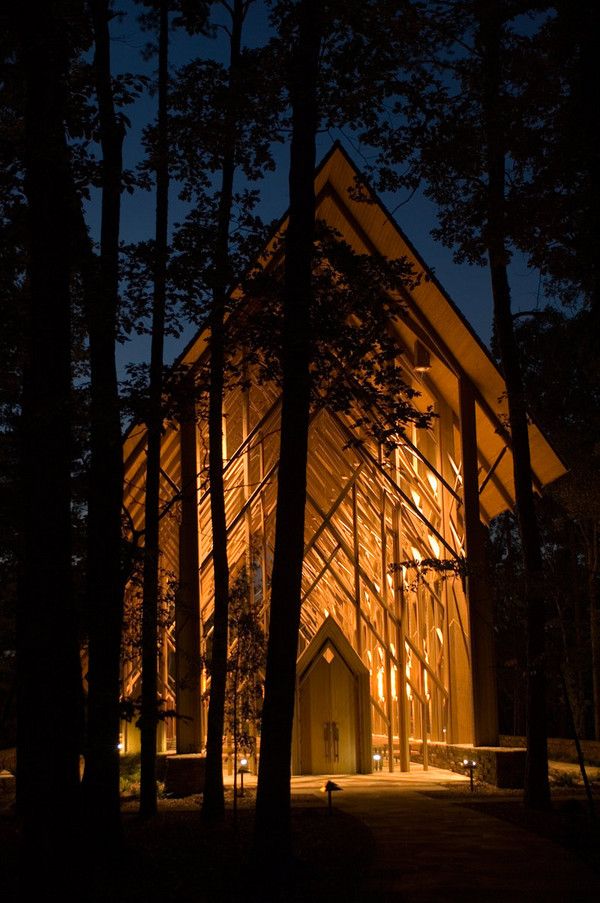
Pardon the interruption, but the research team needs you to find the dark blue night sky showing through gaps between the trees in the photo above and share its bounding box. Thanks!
[98,0,538,365]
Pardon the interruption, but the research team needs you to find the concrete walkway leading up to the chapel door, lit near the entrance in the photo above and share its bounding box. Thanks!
[282,764,600,903]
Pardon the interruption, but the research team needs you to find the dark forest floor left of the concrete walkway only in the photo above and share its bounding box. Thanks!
[0,790,373,903]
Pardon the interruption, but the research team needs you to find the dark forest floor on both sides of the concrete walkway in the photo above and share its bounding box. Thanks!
[0,784,600,903]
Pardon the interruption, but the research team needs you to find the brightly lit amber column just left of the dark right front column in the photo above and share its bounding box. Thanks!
[439,403,479,743]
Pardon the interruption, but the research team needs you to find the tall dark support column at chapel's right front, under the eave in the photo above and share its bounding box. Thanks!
[459,377,498,746]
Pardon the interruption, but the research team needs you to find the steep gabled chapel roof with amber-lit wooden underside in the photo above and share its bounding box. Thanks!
[125,144,565,519]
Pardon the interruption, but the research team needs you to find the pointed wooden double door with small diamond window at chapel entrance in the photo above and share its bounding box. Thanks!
[300,644,358,774]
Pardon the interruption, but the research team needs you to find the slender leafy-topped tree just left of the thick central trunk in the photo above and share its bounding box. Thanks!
[166,0,279,820]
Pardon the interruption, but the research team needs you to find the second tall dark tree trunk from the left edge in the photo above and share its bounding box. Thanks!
[84,0,123,847]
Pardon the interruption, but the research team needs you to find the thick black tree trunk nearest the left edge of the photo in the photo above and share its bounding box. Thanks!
[17,3,83,899]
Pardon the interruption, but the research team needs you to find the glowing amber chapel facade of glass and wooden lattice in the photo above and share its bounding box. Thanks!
[124,147,563,774]
